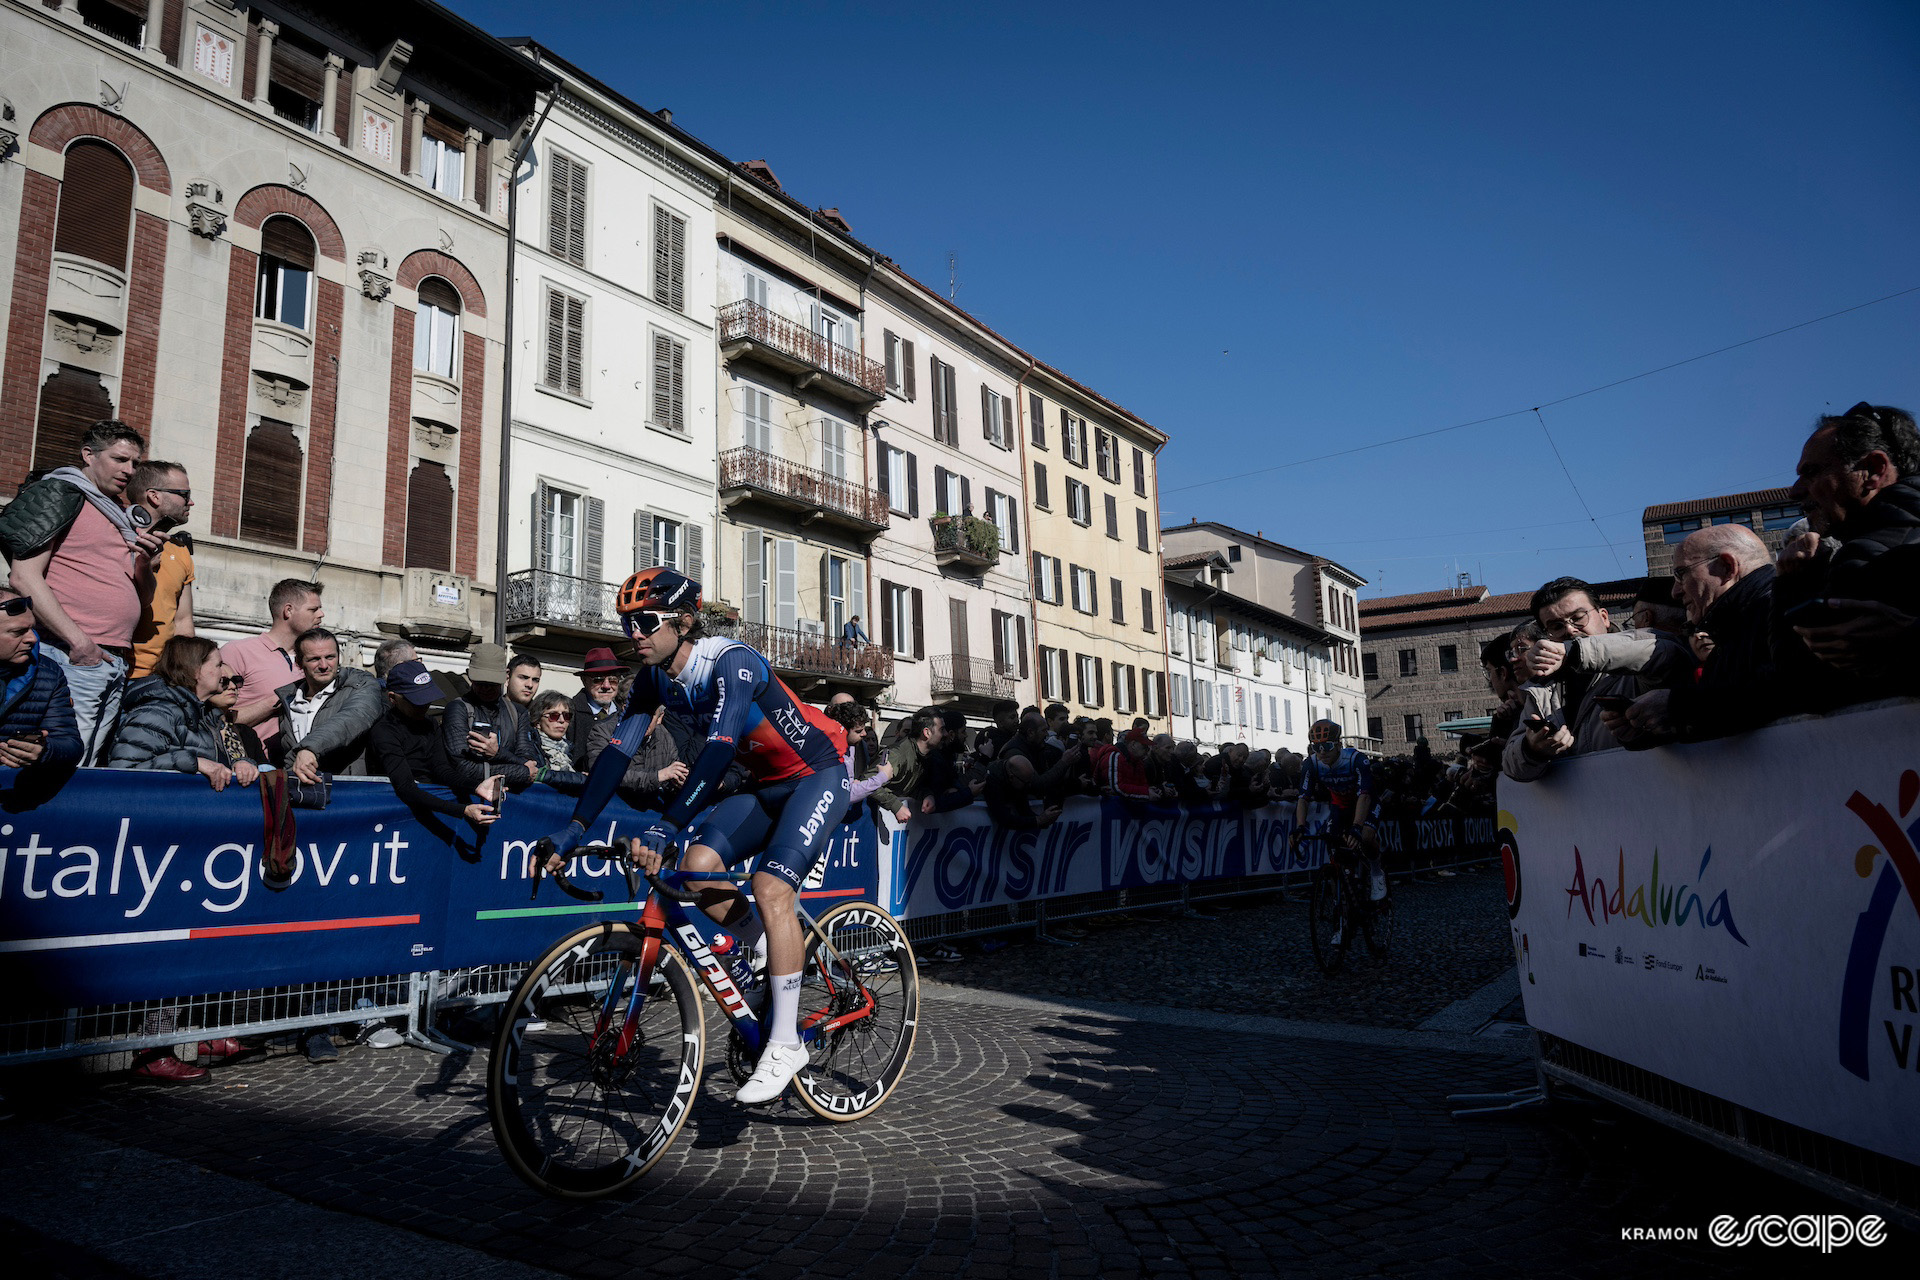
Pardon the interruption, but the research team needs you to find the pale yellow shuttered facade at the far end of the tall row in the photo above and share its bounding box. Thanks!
[1016,376,1167,733]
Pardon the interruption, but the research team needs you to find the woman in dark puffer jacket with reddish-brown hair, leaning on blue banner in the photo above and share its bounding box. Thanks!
[108,635,259,791]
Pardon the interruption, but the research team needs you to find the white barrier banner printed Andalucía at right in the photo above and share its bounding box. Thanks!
[1500,702,1920,1163]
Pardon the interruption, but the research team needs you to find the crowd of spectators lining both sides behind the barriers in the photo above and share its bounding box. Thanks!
[0,403,1920,1079]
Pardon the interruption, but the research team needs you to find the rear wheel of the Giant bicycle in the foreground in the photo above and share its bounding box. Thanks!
[795,902,920,1121]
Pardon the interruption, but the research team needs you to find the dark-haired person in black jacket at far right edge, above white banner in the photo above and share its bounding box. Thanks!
[1772,401,1920,706]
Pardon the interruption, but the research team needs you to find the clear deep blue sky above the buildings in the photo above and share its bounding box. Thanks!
[453,0,1920,595]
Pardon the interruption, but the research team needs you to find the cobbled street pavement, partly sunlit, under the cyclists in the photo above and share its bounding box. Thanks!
[0,875,1910,1280]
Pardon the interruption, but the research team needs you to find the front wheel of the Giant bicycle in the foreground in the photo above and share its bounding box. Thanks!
[488,923,707,1199]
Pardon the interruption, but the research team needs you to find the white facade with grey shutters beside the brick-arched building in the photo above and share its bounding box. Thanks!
[505,40,726,666]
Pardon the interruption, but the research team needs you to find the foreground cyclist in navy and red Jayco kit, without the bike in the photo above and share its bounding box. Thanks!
[543,568,849,1105]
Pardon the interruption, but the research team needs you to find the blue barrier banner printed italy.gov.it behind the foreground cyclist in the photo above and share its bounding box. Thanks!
[0,770,879,1007]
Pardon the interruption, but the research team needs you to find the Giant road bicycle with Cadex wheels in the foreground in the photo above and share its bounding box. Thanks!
[488,846,920,1199]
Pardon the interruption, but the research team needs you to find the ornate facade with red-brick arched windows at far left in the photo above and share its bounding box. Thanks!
[0,0,545,664]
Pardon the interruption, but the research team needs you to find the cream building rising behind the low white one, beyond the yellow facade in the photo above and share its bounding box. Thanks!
[1162,520,1379,750]
